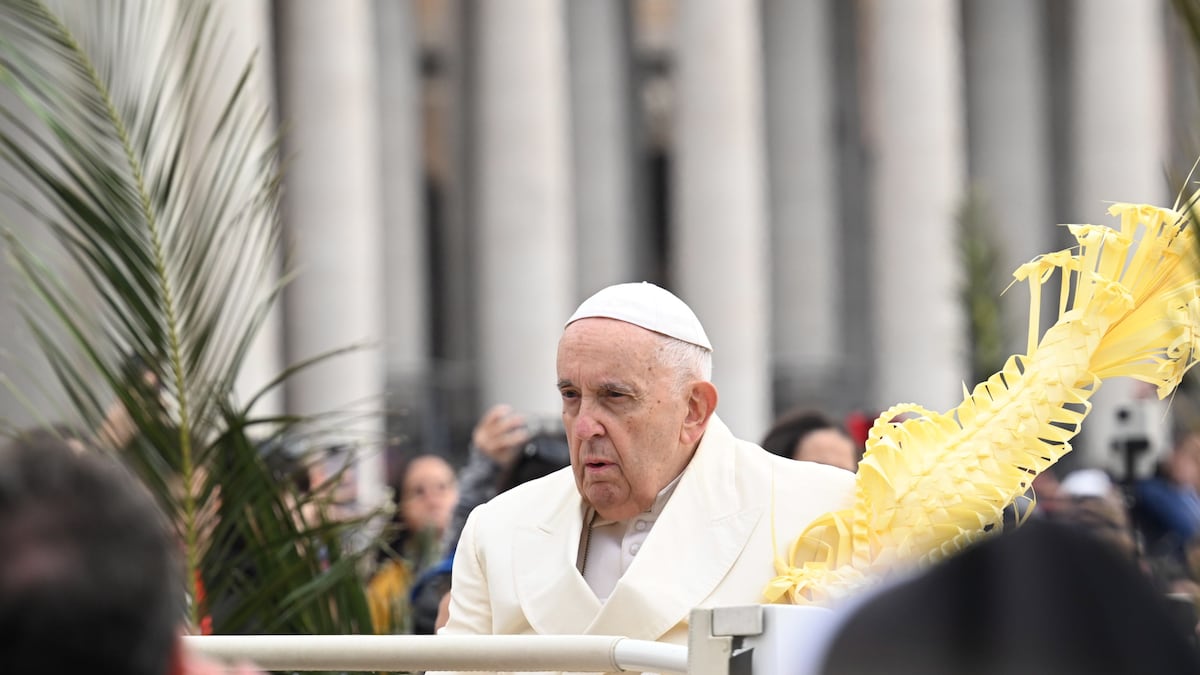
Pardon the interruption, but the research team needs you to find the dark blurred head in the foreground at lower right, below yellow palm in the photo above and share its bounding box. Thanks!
[818,520,1200,675]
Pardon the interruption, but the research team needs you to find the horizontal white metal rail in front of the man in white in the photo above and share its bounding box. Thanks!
[184,635,688,673]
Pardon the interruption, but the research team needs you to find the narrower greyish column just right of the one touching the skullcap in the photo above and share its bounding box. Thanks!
[762,0,845,413]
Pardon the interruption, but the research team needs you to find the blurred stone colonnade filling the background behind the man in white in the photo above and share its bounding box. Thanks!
[0,0,1200,494]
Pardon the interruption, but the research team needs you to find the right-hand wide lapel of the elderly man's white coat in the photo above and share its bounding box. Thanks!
[587,417,764,640]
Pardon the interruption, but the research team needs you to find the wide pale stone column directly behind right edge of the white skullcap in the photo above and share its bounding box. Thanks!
[668,0,772,438]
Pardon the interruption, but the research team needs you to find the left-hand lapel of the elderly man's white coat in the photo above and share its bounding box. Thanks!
[512,468,600,635]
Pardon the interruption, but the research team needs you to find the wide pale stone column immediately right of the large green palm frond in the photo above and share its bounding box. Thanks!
[276,0,385,503]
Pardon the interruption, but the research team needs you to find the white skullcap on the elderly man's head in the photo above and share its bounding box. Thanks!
[564,281,713,351]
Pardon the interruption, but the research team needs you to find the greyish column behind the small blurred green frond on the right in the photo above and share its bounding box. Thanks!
[964,0,1058,355]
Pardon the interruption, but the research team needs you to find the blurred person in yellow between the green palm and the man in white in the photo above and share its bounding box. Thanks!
[367,454,458,633]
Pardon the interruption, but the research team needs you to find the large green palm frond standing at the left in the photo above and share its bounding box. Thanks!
[0,0,379,633]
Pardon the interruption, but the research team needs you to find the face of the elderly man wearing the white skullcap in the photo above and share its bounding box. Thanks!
[558,318,695,520]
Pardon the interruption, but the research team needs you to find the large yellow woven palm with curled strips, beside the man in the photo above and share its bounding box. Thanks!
[764,196,1200,604]
